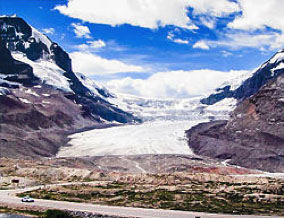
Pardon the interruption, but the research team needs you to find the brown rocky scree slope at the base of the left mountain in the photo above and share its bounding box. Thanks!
[0,86,98,158]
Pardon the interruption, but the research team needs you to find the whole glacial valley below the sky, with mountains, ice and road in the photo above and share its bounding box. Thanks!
[0,16,284,218]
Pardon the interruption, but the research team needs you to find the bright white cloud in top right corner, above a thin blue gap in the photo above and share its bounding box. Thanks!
[229,0,284,31]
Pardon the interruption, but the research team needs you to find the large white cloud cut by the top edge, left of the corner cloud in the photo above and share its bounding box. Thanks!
[55,0,200,29]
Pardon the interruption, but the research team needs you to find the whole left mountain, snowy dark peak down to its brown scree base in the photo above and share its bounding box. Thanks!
[0,17,140,157]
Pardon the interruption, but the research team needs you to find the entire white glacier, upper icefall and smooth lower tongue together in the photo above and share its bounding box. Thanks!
[58,94,233,157]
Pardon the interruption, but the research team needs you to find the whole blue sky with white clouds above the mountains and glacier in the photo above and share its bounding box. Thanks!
[0,0,284,98]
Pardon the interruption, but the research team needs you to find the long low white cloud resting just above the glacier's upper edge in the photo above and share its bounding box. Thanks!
[106,69,246,98]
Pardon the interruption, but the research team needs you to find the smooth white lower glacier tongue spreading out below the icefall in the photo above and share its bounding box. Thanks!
[58,120,207,157]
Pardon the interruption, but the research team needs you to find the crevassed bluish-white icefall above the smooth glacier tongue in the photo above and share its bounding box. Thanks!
[108,94,235,122]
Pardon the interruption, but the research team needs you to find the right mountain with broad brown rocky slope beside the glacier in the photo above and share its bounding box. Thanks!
[186,51,284,172]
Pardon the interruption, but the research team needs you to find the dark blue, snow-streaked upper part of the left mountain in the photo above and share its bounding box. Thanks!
[0,16,138,126]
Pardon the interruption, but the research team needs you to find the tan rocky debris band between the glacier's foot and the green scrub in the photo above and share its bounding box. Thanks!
[0,155,259,188]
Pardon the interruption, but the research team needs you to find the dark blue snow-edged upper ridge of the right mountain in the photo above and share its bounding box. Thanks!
[201,50,284,105]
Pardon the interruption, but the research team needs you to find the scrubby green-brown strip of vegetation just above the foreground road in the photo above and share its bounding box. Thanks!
[19,181,284,218]
